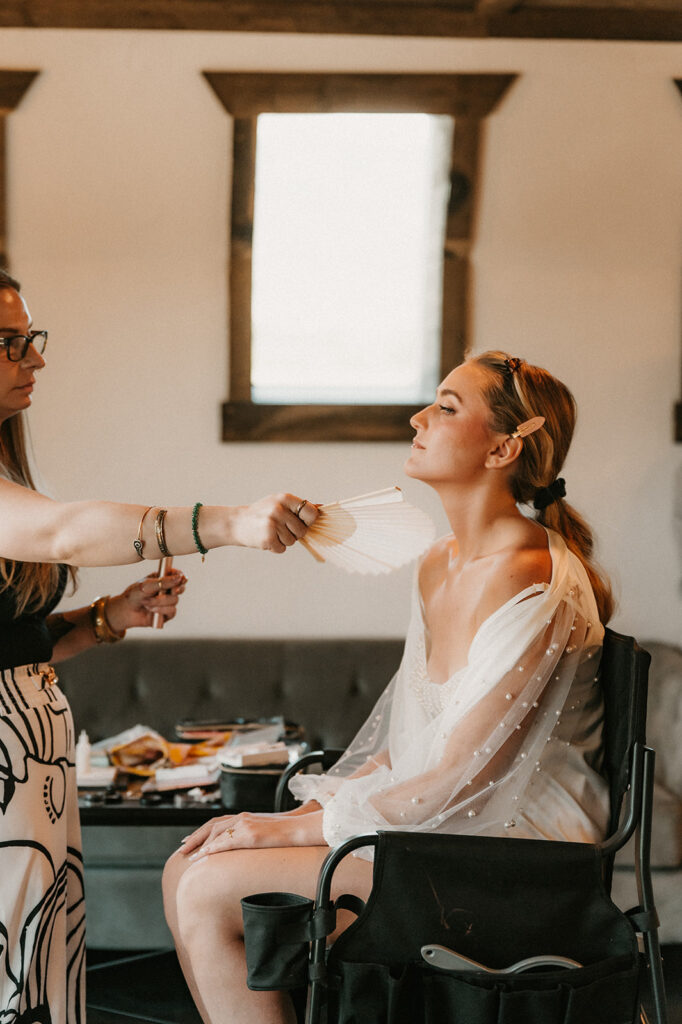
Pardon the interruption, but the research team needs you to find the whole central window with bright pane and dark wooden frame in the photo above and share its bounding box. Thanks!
[201,73,513,440]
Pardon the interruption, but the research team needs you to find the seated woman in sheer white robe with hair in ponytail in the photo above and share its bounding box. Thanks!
[164,352,612,1024]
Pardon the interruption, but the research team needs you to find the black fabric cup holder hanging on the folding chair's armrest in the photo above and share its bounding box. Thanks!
[242,892,313,991]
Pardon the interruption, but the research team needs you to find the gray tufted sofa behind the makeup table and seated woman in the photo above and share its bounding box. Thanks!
[58,639,682,949]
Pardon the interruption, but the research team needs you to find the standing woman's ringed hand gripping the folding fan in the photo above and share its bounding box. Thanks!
[225,494,318,554]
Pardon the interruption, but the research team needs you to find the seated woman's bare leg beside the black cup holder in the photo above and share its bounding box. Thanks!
[164,847,372,1024]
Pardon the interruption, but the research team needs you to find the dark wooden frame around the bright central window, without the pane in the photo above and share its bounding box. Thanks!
[204,71,516,441]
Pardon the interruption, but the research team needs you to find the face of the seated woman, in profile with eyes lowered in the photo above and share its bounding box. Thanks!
[404,362,501,485]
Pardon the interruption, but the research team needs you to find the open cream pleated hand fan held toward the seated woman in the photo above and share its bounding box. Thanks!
[300,487,435,574]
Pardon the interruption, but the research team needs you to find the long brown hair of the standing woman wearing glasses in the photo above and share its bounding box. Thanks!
[0,270,76,617]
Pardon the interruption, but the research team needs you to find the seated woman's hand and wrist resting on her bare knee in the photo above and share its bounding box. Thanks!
[181,810,326,860]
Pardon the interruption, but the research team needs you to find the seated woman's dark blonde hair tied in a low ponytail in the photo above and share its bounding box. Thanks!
[469,352,614,624]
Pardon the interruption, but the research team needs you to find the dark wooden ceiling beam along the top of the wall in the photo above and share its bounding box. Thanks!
[0,0,682,42]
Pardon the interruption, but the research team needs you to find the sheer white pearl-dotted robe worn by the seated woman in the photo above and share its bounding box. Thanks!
[290,530,608,846]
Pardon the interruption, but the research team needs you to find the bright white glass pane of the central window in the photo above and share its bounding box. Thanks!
[251,114,454,404]
